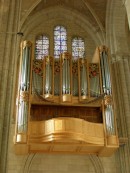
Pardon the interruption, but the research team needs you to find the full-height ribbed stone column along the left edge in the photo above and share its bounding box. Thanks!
[0,0,20,173]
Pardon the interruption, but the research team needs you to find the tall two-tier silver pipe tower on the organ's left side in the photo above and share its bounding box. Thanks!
[17,41,31,133]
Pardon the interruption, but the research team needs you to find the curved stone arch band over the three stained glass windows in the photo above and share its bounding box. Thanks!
[20,6,105,45]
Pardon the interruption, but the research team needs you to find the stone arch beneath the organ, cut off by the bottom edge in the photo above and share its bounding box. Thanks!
[23,154,104,173]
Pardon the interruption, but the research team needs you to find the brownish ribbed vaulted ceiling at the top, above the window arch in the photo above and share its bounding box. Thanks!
[21,0,107,30]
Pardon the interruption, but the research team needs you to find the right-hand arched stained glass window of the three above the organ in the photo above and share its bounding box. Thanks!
[72,37,85,59]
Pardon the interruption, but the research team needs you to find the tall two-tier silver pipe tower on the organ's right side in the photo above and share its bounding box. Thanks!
[100,46,115,135]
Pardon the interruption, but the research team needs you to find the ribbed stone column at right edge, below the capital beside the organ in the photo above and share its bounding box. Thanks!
[112,54,130,173]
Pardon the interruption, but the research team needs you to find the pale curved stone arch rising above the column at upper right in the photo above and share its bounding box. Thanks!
[106,0,128,54]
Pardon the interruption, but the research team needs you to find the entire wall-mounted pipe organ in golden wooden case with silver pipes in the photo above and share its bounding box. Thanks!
[14,41,119,156]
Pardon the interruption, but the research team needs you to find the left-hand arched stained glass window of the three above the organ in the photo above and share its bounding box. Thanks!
[35,35,49,59]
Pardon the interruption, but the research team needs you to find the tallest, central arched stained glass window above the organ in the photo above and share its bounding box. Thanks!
[54,26,67,58]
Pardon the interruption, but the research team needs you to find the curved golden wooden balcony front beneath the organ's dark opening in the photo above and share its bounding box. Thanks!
[28,117,104,145]
